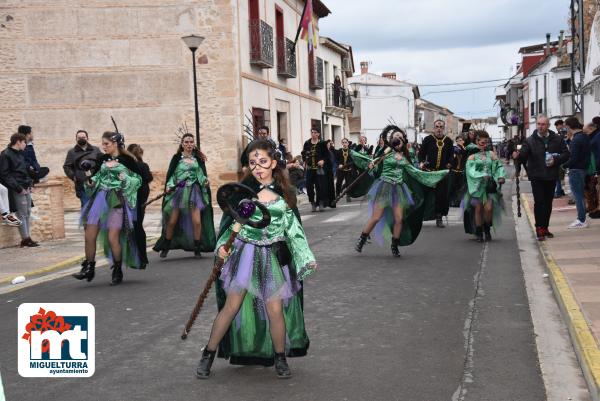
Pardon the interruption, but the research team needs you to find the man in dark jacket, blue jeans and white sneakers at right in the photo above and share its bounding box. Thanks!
[564,117,591,229]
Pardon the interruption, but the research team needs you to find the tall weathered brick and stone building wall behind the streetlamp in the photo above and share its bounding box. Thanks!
[0,0,242,200]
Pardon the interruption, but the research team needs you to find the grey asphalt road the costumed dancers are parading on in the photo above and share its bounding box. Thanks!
[0,184,546,401]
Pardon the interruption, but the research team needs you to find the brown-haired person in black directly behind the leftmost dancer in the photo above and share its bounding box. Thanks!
[127,143,154,268]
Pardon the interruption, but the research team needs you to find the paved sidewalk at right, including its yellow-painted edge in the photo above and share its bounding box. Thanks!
[522,193,600,400]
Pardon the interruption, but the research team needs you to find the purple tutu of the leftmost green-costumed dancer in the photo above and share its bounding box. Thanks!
[80,189,137,230]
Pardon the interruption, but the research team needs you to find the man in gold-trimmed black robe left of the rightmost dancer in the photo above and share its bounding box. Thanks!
[419,120,454,228]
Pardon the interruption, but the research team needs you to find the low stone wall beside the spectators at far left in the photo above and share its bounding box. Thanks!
[0,180,65,248]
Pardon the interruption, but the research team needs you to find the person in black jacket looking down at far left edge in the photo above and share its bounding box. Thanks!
[0,133,39,247]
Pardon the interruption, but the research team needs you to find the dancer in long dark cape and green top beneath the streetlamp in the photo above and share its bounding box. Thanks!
[153,133,216,258]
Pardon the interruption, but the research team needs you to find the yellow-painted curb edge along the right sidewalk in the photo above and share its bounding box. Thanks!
[523,197,600,401]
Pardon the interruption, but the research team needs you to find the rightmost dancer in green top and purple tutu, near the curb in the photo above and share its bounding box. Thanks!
[463,131,506,242]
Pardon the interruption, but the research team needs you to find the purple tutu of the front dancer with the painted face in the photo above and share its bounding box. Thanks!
[220,238,302,302]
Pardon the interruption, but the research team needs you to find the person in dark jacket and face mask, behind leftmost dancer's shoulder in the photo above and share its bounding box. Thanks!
[63,130,102,207]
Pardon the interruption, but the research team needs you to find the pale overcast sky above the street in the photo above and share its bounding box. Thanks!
[320,0,570,118]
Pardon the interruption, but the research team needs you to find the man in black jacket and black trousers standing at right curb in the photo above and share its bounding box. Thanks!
[513,115,569,241]
